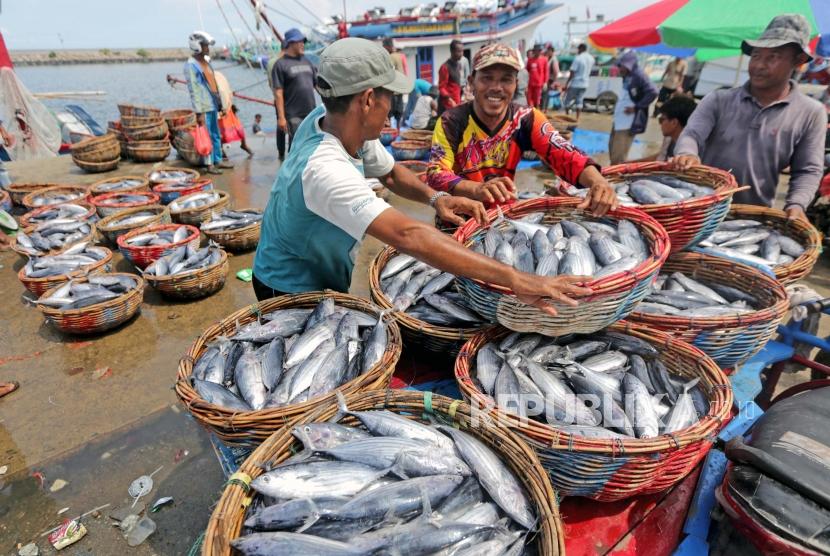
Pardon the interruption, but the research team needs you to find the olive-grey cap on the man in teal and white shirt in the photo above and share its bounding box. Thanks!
[317,37,414,97]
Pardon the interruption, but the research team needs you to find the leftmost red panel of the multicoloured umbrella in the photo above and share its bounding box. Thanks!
[588,0,688,48]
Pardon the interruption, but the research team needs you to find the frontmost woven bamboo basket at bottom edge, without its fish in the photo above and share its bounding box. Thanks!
[202,390,565,556]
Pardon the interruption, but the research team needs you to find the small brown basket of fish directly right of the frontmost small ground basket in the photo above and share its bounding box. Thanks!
[143,245,230,299]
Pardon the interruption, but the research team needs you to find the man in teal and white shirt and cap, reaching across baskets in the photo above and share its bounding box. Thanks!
[253,38,590,312]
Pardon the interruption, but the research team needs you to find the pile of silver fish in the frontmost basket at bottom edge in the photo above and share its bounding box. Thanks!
[231,393,536,556]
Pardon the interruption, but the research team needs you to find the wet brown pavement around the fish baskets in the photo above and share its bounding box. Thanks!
[0,114,830,555]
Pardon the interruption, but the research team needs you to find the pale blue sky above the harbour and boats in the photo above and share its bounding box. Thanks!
[0,0,654,50]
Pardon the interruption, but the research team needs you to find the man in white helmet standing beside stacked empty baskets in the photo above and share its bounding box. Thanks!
[184,31,233,174]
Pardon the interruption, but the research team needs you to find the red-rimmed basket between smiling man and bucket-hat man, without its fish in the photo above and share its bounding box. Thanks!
[602,162,741,253]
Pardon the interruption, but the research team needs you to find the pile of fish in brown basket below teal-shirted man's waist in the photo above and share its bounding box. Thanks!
[193,298,387,411]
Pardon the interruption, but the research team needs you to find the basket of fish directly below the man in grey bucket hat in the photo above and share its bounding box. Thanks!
[699,205,822,285]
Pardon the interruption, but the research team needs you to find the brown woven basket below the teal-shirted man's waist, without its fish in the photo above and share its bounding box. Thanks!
[175,291,401,446]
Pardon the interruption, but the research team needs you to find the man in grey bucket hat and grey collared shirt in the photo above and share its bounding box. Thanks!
[673,14,827,221]
